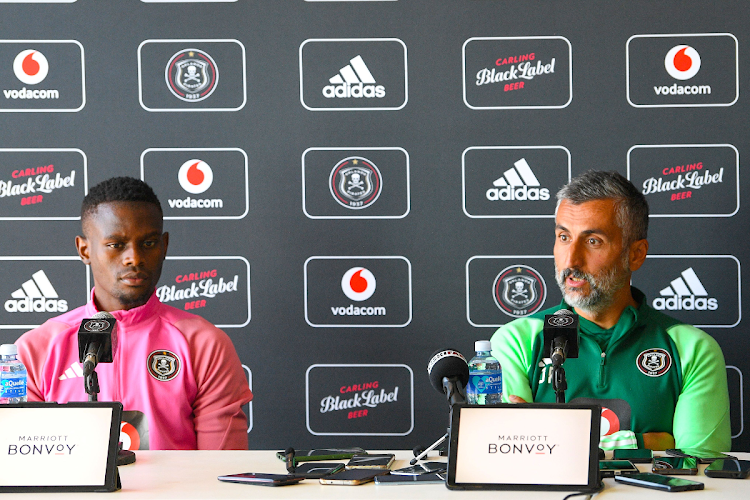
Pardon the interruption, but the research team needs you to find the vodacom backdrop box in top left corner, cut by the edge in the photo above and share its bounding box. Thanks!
[0,40,86,113]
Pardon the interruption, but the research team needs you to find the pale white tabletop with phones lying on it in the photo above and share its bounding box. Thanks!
[3,451,750,500]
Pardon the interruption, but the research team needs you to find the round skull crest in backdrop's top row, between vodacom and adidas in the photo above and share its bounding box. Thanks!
[165,49,219,102]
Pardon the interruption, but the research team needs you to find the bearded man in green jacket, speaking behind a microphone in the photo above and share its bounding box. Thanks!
[492,171,731,451]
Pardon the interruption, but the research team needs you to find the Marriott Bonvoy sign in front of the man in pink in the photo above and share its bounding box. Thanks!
[0,402,122,493]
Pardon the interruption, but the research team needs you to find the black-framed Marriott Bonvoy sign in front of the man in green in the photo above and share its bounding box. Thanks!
[446,404,601,491]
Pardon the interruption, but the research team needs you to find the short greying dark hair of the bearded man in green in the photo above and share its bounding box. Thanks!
[557,170,648,245]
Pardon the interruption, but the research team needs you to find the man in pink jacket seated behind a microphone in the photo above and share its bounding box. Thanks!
[16,177,252,450]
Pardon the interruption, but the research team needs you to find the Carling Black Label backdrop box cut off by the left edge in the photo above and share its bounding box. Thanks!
[0,149,87,220]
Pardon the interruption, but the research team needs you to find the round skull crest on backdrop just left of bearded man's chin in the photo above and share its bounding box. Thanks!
[493,266,547,317]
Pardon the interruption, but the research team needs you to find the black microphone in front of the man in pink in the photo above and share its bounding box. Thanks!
[78,311,117,377]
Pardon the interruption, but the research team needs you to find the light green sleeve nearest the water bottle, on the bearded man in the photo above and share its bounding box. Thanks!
[490,318,543,403]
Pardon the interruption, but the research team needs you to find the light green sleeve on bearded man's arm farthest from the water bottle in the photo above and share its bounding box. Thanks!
[667,325,732,451]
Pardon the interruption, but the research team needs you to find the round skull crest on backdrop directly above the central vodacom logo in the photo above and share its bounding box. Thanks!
[329,156,383,210]
